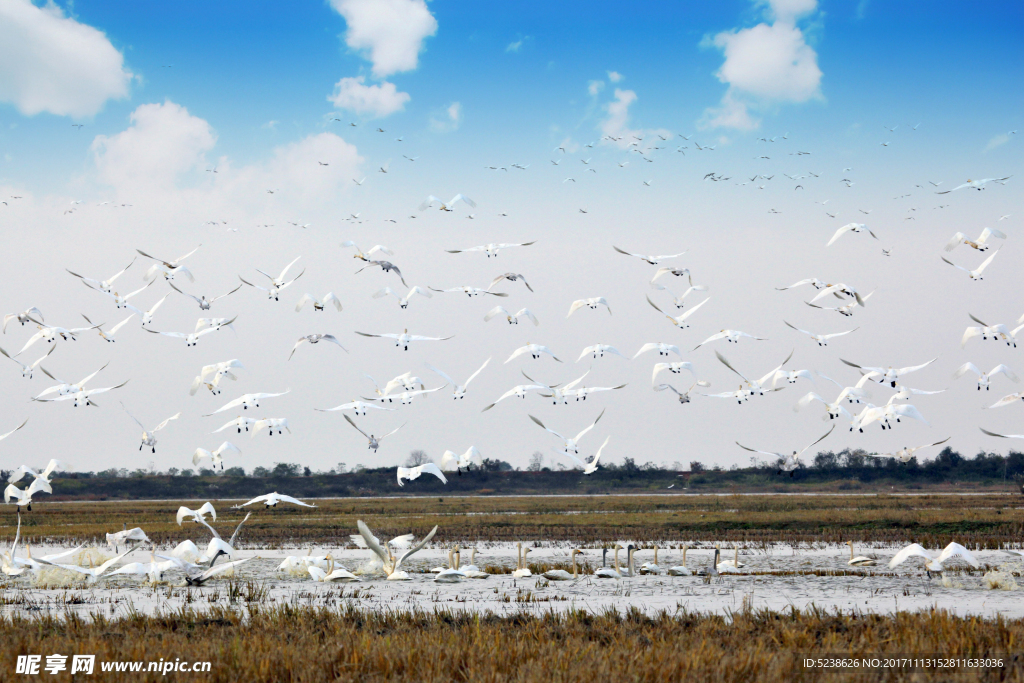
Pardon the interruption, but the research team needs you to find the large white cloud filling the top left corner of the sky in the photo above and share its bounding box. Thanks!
[0,0,132,117]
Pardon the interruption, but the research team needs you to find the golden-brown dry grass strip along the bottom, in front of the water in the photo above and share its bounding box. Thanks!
[0,606,1024,683]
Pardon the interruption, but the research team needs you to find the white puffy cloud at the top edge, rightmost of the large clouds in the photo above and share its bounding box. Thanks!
[701,0,821,130]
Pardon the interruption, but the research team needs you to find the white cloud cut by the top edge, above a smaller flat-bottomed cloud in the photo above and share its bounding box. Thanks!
[331,0,437,78]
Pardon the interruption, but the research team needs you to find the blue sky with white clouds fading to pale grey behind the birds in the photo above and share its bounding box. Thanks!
[0,0,1024,476]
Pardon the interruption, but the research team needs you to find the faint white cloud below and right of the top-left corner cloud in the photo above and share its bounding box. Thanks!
[91,100,217,189]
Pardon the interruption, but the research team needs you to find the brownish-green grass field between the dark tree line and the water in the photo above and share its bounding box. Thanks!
[8,495,1024,548]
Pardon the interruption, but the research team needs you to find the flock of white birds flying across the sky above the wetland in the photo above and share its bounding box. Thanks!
[0,120,1024,518]
